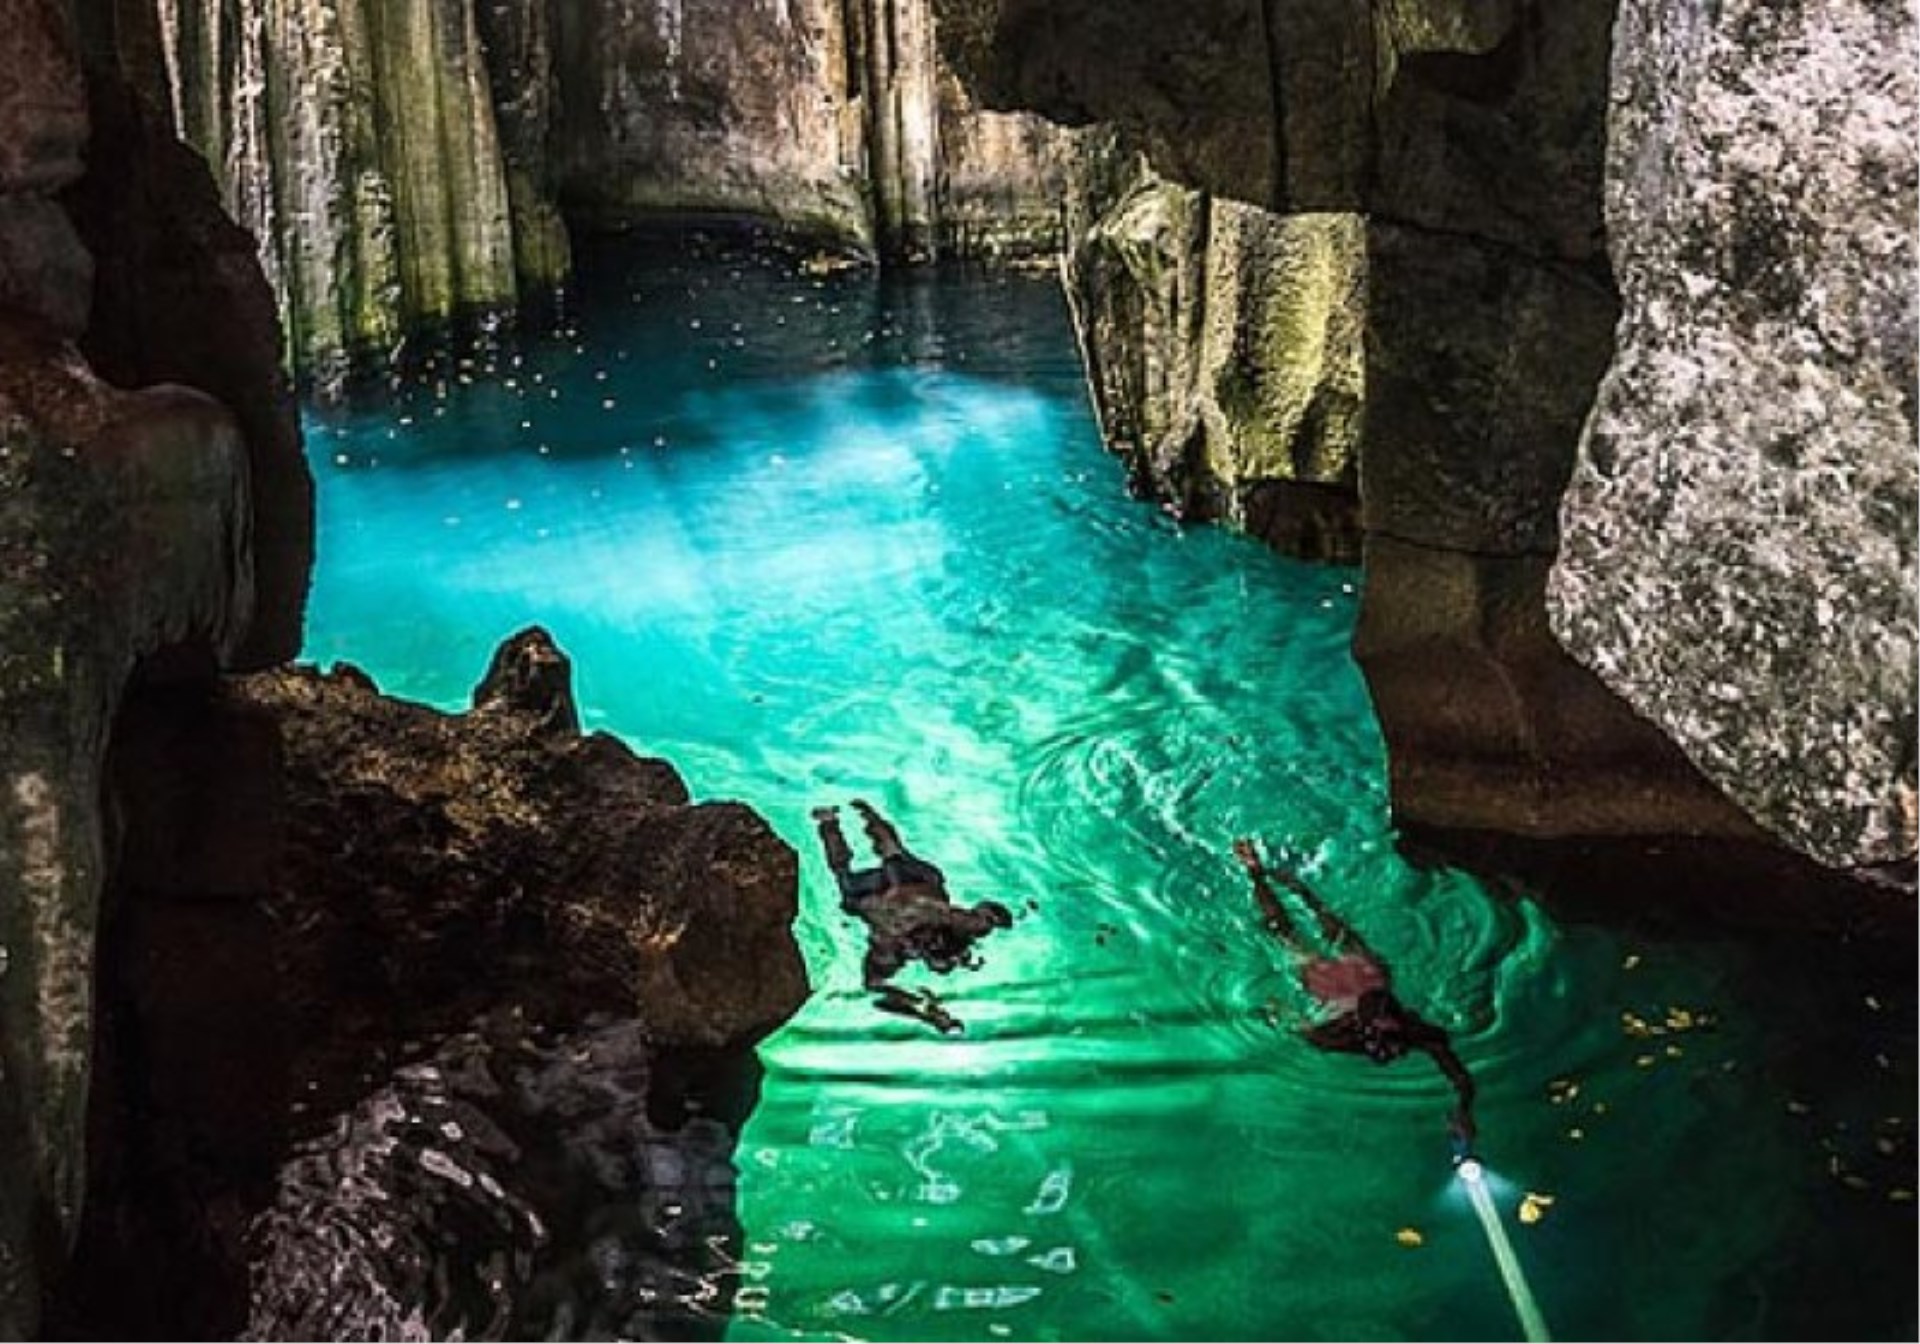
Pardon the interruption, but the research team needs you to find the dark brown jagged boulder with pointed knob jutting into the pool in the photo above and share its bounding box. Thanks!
[61,632,806,1336]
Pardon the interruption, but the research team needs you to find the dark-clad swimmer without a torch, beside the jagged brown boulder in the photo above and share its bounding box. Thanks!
[814,799,1014,1031]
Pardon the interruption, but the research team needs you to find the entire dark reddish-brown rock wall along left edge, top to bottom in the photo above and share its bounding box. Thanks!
[0,0,311,1334]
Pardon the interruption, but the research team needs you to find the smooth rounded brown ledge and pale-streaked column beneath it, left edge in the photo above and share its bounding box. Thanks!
[0,315,253,1334]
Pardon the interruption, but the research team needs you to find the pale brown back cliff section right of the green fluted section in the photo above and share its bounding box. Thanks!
[520,0,1069,261]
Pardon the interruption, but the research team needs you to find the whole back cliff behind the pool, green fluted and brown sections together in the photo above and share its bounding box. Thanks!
[142,0,1066,376]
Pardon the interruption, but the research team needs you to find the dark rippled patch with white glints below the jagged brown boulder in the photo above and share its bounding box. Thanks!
[242,1014,743,1340]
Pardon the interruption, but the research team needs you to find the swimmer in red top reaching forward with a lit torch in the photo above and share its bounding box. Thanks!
[1233,839,1475,1156]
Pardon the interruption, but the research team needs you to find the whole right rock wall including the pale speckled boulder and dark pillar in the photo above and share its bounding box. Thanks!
[939,0,1914,883]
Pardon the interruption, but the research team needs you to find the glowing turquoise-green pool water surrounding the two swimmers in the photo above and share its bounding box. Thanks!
[307,243,1914,1340]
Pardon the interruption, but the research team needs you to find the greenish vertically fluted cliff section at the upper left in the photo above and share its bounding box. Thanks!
[156,0,533,374]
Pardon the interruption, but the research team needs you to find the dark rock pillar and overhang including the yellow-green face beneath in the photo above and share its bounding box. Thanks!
[941,0,1753,848]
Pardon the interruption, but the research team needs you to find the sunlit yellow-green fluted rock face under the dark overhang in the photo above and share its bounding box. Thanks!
[1066,136,1367,561]
